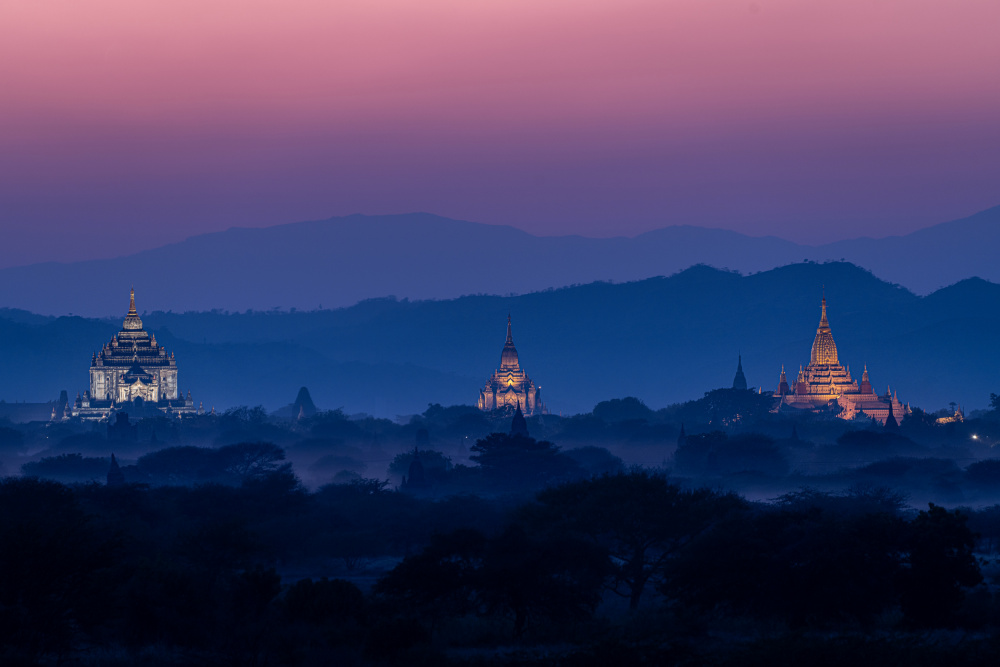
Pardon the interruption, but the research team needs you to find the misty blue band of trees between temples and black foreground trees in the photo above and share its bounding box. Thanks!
[9,390,1000,505]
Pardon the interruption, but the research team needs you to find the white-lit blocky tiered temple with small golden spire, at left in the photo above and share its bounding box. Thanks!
[72,289,197,419]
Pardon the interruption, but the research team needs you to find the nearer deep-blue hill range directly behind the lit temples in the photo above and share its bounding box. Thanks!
[0,262,1000,416]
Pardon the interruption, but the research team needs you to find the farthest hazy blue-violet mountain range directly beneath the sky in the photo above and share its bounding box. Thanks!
[0,207,1000,316]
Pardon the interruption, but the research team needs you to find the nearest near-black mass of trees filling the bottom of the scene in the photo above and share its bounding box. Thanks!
[0,464,1000,666]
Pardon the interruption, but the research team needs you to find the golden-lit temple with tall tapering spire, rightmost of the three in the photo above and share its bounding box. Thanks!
[774,296,910,424]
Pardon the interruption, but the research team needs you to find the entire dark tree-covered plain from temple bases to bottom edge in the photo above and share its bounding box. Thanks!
[0,390,1000,666]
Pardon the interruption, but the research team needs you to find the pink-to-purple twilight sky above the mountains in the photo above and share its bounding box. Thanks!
[0,0,1000,268]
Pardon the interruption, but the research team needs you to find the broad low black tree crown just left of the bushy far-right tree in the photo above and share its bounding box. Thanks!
[663,506,904,626]
